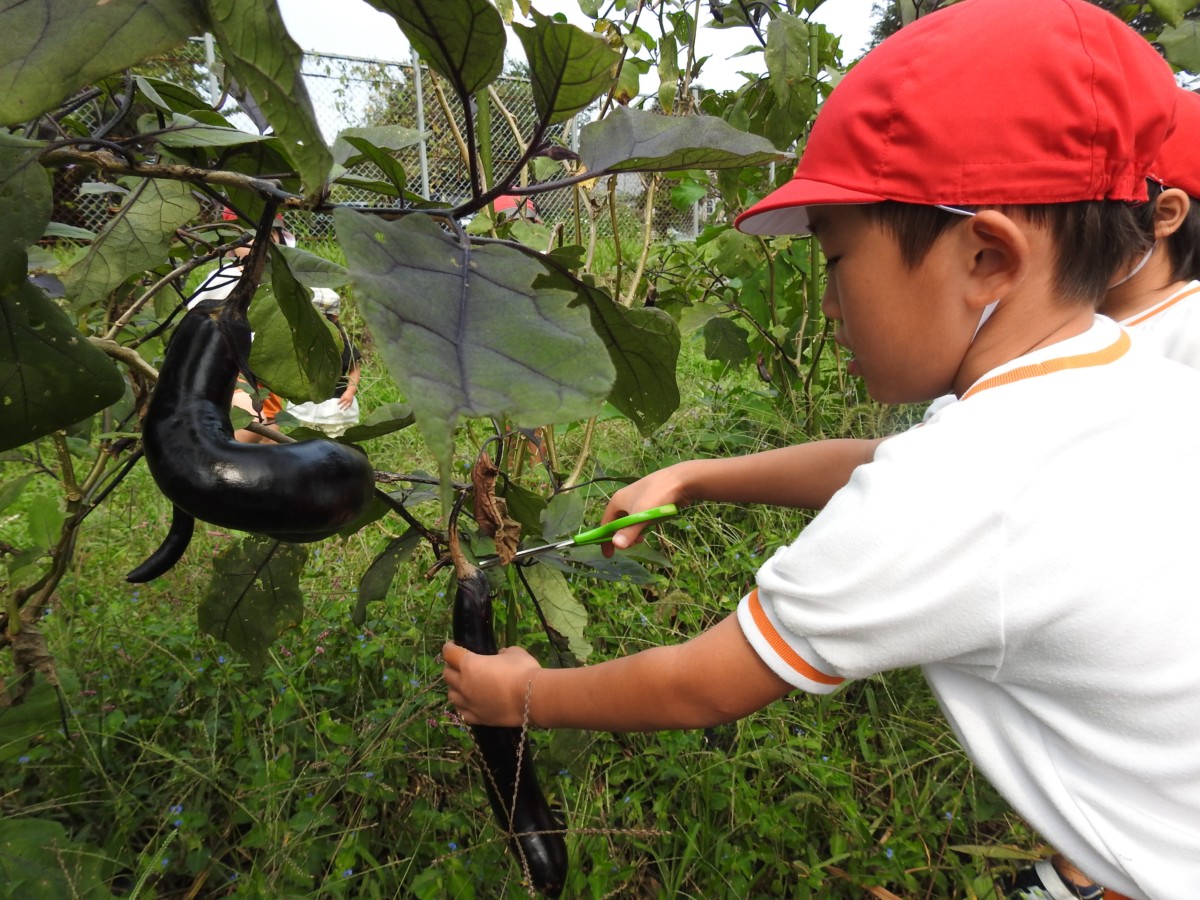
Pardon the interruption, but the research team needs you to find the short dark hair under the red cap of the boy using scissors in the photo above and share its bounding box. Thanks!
[860,200,1152,306]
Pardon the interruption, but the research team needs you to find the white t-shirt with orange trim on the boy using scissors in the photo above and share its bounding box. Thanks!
[738,317,1200,898]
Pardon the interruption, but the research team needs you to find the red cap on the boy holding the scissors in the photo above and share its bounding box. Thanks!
[734,0,1178,234]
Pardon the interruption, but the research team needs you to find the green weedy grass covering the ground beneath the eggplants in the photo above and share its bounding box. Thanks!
[0,266,1037,899]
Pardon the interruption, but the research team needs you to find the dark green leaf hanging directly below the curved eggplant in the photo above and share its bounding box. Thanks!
[197,535,308,670]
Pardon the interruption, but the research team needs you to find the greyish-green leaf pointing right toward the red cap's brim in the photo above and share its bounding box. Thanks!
[580,107,787,174]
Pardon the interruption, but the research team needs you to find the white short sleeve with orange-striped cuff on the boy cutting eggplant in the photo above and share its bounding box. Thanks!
[738,426,1004,692]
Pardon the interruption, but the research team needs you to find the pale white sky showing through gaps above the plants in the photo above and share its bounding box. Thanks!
[278,0,875,90]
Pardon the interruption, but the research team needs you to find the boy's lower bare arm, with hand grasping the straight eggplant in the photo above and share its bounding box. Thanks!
[442,616,792,731]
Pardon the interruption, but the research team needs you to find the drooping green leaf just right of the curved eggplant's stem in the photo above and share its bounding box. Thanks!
[250,246,342,403]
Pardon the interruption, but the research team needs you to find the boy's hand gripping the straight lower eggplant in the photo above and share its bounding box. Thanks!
[442,641,541,727]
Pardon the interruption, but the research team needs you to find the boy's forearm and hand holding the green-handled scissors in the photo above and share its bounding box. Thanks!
[601,438,884,551]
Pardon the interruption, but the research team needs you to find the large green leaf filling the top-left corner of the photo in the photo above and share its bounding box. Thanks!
[0,0,208,125]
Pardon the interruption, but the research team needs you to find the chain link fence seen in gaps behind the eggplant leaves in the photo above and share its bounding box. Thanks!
[55,38,715,247]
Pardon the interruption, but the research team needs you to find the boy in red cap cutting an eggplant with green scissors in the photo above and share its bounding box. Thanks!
[444,0,1200,898]
